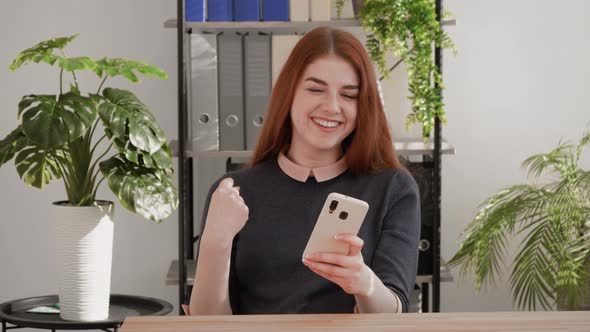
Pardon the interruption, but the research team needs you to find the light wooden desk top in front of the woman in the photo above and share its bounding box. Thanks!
[119,311,590,332]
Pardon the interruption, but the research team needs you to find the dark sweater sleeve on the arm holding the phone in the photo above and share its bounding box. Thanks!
[372,171,420,312]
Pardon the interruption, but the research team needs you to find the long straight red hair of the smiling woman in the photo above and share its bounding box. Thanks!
[251,27,403,174]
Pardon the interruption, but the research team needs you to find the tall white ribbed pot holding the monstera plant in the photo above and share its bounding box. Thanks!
[53,201,114,321]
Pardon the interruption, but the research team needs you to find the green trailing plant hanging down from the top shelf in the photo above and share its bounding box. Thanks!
[336,0,455,139]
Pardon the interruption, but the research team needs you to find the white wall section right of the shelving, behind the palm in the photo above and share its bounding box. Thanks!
[441,0,590,311]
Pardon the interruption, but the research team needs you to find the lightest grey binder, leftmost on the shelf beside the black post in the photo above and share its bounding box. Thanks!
[187,34,219,151]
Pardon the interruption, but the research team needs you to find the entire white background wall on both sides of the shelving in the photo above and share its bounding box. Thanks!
[0,0,590,322]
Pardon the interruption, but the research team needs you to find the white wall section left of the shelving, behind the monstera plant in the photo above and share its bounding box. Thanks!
[0,0,178,322]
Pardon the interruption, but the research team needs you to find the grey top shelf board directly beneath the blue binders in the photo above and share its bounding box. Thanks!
[164,18,457,34]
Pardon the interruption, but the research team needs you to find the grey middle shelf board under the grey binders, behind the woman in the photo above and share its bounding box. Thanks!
[170,137,455,158]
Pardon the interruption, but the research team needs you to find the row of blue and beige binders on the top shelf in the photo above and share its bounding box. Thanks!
[185,0,332,22]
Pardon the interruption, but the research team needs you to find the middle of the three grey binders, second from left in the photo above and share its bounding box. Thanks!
[217,32,245,150]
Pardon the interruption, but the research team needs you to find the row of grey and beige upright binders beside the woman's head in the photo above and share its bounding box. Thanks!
[187,32,301,151]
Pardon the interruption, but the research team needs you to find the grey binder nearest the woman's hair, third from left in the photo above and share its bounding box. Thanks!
[244,34,272,150]
